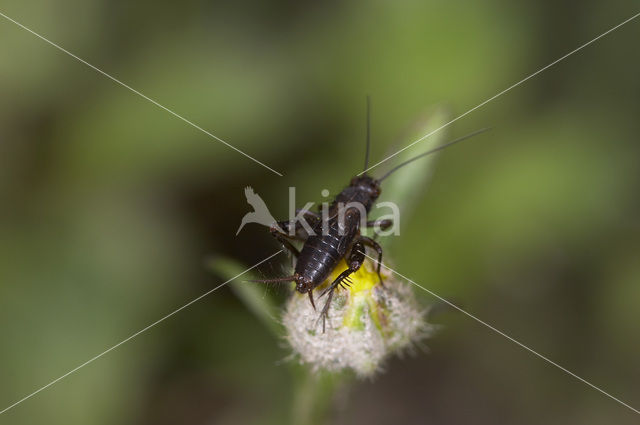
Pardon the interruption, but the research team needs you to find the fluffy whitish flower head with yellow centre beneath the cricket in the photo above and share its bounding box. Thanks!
[283,260,434,377]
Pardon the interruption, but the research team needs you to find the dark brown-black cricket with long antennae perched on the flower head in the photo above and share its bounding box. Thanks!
[255,98,488,332]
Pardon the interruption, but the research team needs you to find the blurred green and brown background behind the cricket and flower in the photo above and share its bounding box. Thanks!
[0,0,640,425]
